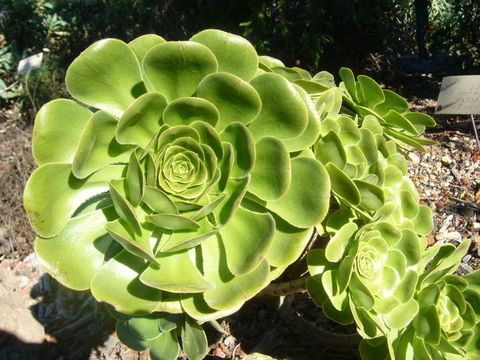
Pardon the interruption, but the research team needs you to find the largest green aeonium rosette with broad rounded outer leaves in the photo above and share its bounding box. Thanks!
[24,30,330,334]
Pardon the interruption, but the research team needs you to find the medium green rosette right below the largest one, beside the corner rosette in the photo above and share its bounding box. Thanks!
[308,221,434,339]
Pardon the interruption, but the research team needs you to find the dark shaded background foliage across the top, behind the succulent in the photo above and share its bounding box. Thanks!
[0,0,480,120]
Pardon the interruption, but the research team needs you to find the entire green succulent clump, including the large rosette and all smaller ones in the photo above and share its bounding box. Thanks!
[24,26,472,360]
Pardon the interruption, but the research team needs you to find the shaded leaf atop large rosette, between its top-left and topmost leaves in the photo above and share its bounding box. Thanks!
[143,41,218,101]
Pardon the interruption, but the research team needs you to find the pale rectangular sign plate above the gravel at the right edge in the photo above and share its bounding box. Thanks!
[435,75,480,115]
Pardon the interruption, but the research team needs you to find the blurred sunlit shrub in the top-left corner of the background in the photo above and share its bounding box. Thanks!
[0,0,68,122]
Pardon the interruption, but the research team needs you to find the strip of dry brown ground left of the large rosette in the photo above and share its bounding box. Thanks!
[0,110,35,259]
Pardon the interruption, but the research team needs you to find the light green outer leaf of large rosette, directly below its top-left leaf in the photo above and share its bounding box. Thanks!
[32,99,92,165]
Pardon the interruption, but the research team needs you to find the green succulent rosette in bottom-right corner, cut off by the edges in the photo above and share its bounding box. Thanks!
[360,241,480,360]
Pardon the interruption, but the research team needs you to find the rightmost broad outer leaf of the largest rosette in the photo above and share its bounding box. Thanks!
[266,157,330,228]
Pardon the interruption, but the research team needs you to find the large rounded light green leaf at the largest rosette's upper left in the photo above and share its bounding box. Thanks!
[65,39,145,116]
